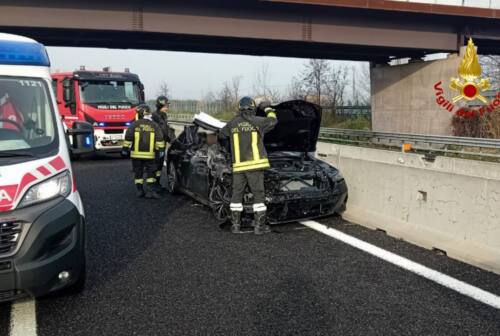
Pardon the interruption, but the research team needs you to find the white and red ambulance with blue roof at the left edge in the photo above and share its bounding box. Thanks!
[0,33,93,301]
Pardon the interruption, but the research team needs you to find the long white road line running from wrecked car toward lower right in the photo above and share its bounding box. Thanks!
[301,221,500,309]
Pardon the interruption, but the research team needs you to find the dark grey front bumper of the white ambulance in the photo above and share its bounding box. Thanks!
[0,199,85,301]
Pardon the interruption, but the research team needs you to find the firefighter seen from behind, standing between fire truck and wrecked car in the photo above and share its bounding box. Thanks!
[122,104,165,199]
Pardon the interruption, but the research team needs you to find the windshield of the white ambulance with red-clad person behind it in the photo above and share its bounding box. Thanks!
[0,77,58,159]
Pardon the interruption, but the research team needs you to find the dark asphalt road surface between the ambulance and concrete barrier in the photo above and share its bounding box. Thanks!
[0,159,500,336]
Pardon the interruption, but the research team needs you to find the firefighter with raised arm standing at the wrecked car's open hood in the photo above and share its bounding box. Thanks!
[220,97,278,234]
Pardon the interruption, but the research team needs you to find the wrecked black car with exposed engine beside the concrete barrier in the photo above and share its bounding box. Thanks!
[167,102,348,224]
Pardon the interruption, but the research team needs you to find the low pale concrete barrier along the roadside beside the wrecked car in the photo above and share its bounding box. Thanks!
[317,143,500,274]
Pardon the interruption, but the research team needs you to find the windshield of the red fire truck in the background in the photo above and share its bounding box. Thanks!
[79,80,140,104]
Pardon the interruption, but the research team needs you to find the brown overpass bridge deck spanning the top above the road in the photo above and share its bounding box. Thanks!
[0,0,500,63]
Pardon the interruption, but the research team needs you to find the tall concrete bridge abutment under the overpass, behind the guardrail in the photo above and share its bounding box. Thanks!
[370,55,460,135]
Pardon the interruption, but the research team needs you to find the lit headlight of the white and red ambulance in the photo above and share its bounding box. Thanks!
[19,170,71,207]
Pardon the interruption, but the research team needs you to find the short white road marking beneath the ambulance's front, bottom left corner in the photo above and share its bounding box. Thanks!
[10,299,37,336]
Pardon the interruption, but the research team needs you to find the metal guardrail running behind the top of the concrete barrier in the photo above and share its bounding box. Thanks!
[171,115,500,162]
